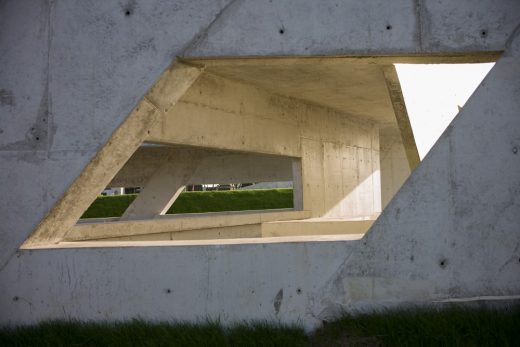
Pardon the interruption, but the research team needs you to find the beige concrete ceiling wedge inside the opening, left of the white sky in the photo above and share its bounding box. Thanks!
[191,58,397,128]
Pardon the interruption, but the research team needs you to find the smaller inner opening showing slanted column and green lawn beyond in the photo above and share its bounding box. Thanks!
[80,144,301,222]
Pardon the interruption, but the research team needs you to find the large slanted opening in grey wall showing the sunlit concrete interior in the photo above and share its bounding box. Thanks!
[21,56,500,249]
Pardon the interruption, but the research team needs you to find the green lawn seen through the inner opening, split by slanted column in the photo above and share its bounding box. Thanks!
[81,189,293,218]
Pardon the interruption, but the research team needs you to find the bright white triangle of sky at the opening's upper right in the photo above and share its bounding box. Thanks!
[395,63,494,159]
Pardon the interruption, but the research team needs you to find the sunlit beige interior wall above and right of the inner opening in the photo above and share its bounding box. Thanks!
[147,74,381,218]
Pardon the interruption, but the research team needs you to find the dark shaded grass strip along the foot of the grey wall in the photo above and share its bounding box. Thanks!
[0,308,520,347]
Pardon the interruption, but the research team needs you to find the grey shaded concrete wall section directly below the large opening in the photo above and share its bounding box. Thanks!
[0,241,360,325]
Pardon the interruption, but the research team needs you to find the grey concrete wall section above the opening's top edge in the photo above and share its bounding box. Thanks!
[185,0,520,56]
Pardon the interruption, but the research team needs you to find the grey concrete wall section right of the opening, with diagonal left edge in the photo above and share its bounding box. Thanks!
[312,33,520,315]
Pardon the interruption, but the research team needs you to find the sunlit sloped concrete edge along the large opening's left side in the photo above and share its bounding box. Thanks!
[22,64,201,248]
